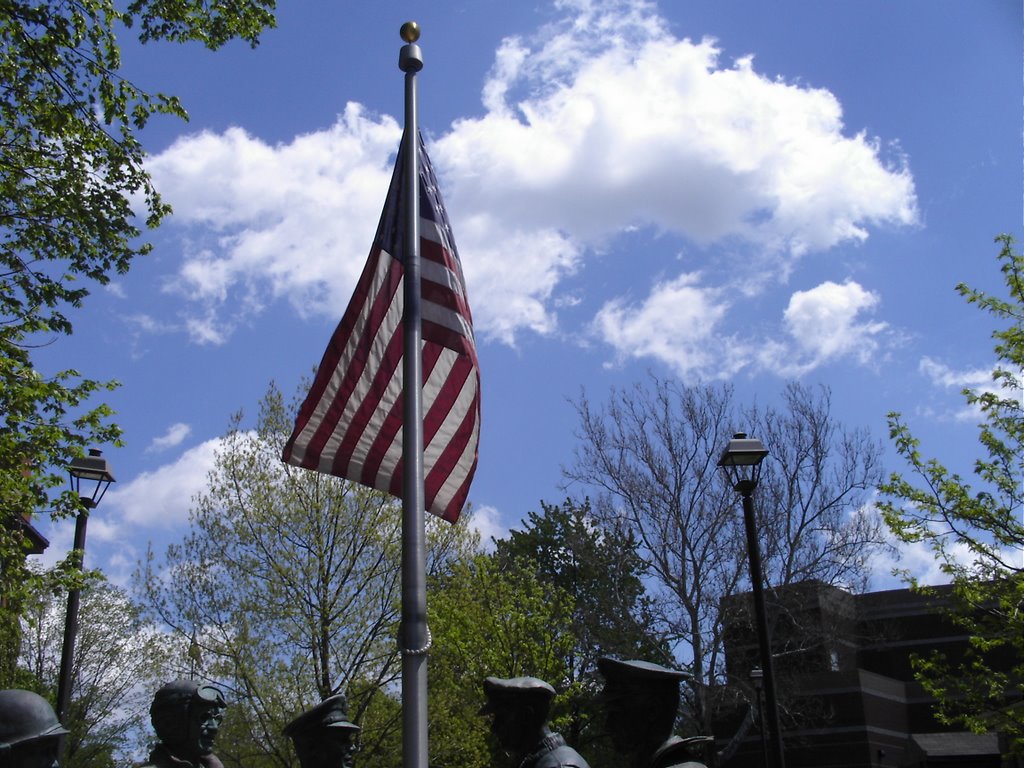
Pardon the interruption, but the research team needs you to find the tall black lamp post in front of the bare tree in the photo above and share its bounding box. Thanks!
[718,432,785,768]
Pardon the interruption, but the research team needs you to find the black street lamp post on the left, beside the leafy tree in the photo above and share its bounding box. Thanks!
[56,449,114,723]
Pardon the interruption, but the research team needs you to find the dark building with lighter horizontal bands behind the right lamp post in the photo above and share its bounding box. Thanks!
[713,582,1024,768]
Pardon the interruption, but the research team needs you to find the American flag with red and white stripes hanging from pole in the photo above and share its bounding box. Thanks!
[283,136,480,522]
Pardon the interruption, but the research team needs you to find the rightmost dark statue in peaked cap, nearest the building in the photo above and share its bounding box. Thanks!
[597,657,710,768]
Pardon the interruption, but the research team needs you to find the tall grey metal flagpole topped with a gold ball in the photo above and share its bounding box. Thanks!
[398,22,430,768]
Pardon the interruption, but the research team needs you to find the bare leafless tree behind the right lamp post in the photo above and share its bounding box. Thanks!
[564,377,882,734]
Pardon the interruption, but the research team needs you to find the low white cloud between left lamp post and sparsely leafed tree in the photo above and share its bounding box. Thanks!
[103,438,221,528]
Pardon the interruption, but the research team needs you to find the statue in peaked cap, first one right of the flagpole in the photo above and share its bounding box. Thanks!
[480,677,590,768]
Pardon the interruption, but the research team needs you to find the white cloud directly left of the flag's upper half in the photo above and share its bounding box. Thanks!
[147,103,400,343]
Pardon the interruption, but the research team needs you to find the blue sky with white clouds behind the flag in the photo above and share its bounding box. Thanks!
[34,0,1024,588]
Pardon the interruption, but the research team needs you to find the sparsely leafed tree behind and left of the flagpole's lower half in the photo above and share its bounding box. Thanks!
[138,385,475,766]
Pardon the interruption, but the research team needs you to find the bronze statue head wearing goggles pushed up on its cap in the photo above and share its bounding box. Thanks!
[142,680,227,768]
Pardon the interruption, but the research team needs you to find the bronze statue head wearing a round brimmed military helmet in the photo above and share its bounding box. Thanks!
[0,688,68,768]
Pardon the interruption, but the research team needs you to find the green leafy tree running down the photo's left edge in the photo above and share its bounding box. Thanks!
[0,0,274,685]
